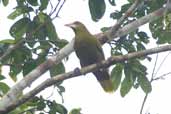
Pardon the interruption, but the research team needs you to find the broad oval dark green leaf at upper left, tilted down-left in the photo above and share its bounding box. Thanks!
[10,17,31,41]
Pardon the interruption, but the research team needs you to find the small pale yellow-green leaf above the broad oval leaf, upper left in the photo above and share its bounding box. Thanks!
[8,6,33,20]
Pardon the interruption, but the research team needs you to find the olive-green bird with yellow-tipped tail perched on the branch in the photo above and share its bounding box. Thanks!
[66,21,113,92]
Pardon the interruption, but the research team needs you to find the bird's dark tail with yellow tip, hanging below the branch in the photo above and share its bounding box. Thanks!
[93,69,114,93]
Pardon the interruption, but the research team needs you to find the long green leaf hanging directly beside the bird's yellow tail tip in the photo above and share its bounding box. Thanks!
[111,64,123,91]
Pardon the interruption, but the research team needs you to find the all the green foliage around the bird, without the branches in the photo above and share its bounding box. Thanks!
[0,0,171,114]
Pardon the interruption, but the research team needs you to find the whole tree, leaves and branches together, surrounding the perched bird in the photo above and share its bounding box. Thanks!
[0,0,171,114]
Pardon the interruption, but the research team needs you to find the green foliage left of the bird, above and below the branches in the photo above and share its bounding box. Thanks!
[0,0,68,114]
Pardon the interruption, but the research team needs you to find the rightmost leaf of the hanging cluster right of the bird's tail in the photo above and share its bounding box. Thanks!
[138,76,152,94]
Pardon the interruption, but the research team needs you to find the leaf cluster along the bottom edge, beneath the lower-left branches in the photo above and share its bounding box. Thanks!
[10,96,68,114]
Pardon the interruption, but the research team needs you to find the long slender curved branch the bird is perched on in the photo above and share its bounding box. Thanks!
[0,45,171,114]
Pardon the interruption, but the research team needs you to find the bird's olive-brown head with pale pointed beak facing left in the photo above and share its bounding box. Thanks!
[65,21,87,34]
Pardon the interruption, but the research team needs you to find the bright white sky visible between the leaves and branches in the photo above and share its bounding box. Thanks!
[0,0,171,114]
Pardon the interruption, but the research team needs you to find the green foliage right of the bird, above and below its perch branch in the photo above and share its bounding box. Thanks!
[102,0,171,97]
